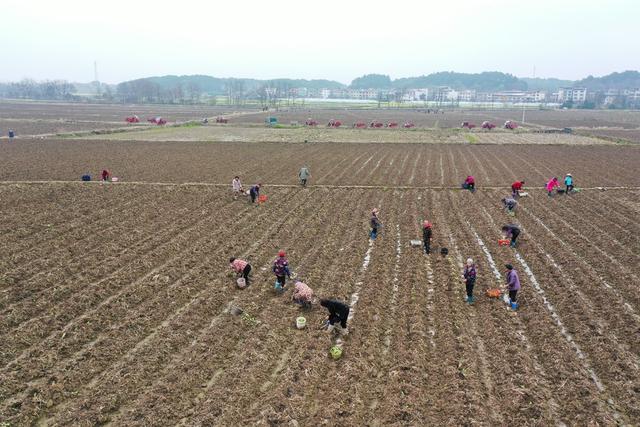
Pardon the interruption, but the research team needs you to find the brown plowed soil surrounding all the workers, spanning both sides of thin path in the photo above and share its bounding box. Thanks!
[0,105,640,427]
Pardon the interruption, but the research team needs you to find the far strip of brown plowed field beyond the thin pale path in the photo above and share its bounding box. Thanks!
[0,140,640,188]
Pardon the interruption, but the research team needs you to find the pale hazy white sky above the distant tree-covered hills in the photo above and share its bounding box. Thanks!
[0,0,640,83]
